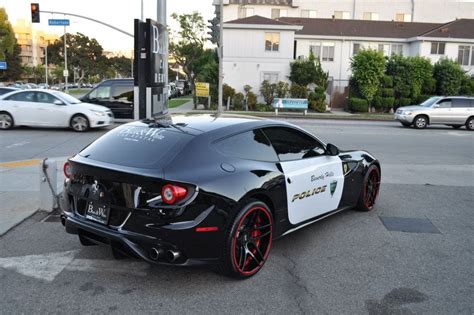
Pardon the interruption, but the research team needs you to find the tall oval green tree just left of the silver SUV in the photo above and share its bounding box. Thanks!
[351,49,385,110]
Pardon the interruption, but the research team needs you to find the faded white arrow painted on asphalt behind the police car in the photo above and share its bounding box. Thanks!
[0,250,150,282]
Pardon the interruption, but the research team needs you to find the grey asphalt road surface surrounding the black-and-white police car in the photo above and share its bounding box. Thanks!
[0,120,474,314]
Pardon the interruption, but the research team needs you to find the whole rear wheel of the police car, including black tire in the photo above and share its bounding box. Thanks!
[219,200,273,279]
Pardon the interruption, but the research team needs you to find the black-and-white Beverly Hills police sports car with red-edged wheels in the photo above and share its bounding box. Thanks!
[61,115,381,278]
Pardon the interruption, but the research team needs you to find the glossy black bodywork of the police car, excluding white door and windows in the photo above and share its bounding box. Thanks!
[62,118,378,265]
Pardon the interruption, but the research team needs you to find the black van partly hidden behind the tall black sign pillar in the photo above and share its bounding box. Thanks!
[80,79,134,119]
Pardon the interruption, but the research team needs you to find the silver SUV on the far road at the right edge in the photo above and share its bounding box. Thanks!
[395,96,474,130]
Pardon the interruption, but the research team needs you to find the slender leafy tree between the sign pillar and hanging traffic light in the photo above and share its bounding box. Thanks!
[169,12,206,108]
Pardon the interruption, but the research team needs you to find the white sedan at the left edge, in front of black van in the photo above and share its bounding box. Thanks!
[0,89,113,131]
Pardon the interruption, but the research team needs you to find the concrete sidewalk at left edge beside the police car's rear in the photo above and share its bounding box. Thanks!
[0,157,67,236]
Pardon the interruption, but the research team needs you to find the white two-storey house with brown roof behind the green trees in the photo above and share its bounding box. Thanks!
[223,17,474,107]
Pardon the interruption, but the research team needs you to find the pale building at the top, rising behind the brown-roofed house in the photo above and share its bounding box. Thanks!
[223,0,474,23]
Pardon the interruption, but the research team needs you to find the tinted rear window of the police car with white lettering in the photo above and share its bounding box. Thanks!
[79,125,193,168]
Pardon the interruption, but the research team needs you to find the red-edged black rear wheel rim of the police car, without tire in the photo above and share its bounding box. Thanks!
[232,207,272,276]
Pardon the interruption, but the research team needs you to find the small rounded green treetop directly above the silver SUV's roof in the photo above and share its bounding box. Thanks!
[433,58,466,95]
